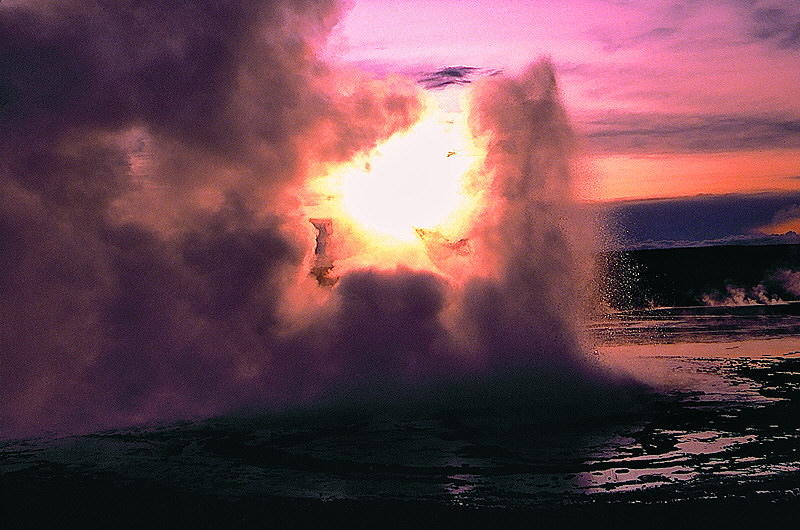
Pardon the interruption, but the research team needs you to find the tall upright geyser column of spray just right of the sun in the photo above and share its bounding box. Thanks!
[450,61,592,372]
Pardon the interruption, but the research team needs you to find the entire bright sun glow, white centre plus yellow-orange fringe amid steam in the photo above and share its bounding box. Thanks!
[302,104,480,274]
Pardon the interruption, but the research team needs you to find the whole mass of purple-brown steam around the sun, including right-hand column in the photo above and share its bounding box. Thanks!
[0,0,632,436]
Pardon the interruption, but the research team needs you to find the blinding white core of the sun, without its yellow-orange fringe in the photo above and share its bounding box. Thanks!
[341,117,471,241]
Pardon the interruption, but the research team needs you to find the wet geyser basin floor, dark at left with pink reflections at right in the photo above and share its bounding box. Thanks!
[0,312,800,524]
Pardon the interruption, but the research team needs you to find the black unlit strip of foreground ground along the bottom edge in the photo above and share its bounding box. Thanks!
[2,481,800,528]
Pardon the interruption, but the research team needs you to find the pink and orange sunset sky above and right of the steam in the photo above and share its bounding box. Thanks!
[328,0,800,200]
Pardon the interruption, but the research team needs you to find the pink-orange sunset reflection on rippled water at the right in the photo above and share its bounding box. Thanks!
[579,314,800,498]
